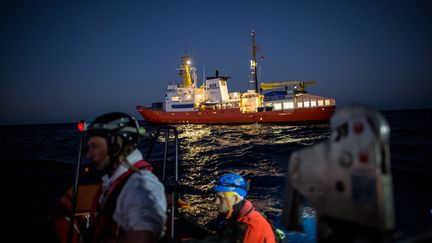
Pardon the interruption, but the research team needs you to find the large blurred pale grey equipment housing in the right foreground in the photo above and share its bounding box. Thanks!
[281,106,395,242]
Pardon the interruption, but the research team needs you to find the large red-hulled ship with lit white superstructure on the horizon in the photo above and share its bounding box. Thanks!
[136,31,336,124]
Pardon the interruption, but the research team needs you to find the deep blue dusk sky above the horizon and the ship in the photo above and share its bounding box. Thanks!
[0,0,432,125]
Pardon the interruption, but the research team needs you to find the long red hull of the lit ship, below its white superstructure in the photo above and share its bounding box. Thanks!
[137,106,336,124]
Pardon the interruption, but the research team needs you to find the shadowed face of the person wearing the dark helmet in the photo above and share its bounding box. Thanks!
[87,136,110,169]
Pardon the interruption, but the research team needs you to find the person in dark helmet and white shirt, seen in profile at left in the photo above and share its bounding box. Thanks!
[87,112,167,242]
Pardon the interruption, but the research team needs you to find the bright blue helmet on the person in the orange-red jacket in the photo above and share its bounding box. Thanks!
[213,173,249,197]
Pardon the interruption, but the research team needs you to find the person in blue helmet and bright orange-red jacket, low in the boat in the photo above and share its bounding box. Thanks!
[214,173,276,243]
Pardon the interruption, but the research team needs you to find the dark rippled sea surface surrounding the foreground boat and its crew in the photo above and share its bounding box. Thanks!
[0,110,432,242]
